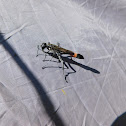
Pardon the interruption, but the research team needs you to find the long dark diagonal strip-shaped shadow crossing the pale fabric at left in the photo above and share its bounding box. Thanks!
[0,33,65,126]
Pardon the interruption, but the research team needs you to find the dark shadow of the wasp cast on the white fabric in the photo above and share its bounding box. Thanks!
[42,52,100,82]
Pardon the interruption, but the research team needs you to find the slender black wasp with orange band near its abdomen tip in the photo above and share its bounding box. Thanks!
[37,42,84,82]
